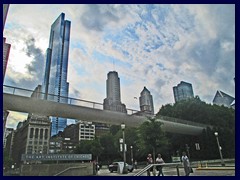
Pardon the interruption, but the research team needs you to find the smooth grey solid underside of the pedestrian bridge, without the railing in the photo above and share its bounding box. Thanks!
[3,93,205,135]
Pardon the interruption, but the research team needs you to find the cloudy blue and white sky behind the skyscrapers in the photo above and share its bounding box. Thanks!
[3,4,235,128]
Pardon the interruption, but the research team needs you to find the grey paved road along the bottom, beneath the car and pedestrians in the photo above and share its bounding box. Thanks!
[97,168,235,176]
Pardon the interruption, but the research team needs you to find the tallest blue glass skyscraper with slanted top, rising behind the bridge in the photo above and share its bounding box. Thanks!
[42,13,71,135]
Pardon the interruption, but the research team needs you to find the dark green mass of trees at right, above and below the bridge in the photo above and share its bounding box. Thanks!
[156,97,235,159]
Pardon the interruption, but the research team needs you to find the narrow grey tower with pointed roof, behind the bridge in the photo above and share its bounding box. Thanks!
[139,86,154,114]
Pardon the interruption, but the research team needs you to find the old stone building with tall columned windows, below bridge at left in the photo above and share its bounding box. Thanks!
[9,115,51,164]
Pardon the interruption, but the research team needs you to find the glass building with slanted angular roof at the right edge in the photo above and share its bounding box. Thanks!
[213,90,235,109]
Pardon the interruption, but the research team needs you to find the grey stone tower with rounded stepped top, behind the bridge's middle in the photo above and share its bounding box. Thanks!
[103,71,127,113]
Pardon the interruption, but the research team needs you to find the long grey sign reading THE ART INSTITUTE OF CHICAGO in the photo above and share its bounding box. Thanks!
[21,154,92,161]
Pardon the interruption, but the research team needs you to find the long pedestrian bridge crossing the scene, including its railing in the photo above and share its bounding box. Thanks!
[3,85,211,135]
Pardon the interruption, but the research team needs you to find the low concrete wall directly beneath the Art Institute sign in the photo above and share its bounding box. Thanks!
[20,163,94,176]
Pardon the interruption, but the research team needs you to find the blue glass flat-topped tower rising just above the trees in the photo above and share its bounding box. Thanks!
[173,81,194,102]
